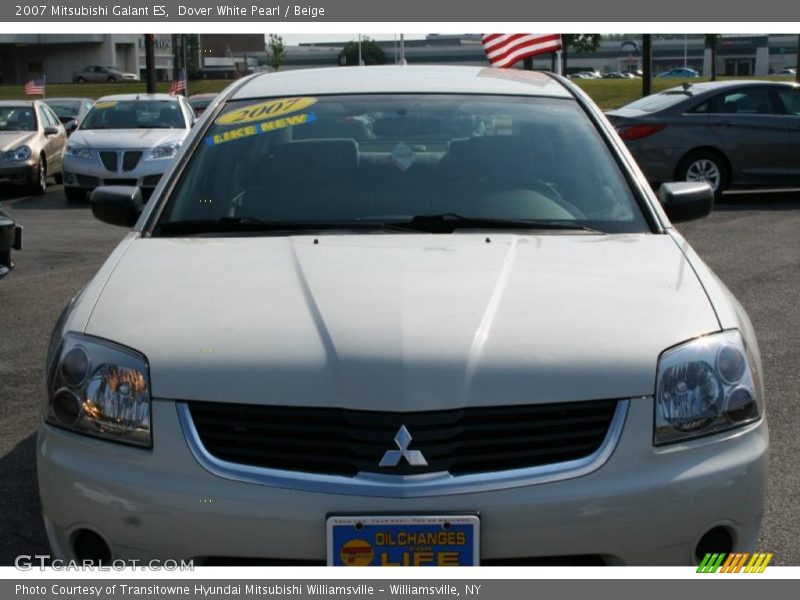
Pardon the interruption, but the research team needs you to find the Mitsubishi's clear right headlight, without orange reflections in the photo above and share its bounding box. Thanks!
[654,331,761,445]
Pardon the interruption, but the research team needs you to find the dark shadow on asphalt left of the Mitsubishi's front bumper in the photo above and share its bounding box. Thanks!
[0,433,50,565]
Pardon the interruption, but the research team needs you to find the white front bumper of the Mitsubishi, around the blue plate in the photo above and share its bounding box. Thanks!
[37,398,768,565]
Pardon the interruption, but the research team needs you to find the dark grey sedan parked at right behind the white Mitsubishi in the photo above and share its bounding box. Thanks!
[606,80,800,196]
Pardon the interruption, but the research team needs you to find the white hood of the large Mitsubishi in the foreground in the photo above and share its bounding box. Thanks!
[85,234,719,411]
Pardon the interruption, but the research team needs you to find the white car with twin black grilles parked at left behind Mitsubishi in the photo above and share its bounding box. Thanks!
[64,94,195,202]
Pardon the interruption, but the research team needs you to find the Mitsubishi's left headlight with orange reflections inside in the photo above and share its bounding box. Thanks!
[45,333,152,448]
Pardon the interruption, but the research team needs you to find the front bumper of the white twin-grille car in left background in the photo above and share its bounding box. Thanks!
[64,150,171,191]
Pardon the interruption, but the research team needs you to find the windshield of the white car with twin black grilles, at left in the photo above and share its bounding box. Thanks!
[81,100,186,129]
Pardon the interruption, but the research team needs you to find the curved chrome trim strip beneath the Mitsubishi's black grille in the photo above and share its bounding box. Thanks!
[176,400,630,498]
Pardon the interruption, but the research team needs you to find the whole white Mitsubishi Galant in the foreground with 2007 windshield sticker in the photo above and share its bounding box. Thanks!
[37,66,768,565]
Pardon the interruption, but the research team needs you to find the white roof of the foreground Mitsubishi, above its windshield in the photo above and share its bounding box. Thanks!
[232,65,572,100]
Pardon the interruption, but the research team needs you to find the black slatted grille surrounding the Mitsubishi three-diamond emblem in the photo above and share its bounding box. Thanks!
[188,400,617,477]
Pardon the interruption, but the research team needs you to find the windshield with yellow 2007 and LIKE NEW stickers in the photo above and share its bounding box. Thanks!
[153,94,649,235]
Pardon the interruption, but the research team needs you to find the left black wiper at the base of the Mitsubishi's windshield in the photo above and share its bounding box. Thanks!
[154,217,416,235]
